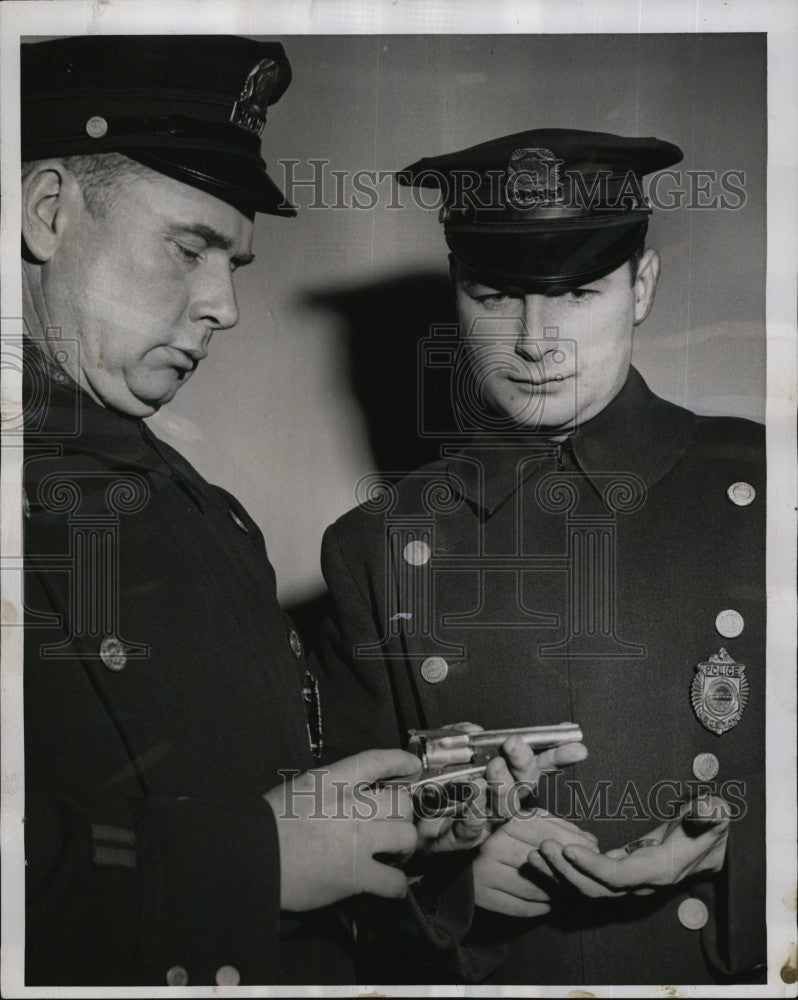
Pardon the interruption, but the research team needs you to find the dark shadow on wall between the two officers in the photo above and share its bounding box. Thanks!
[285,272,457,649]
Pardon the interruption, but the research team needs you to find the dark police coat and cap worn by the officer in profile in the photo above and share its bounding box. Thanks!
[22,36,346,986]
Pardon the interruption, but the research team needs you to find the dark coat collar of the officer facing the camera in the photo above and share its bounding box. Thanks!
[446,368,696,516]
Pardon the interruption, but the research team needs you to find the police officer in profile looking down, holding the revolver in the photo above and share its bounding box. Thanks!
[22,36,540,986]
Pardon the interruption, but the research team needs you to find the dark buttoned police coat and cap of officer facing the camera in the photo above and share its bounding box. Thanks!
[322,131,765,984]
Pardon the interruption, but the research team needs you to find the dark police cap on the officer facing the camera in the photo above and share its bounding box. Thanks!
[398,129,683,290]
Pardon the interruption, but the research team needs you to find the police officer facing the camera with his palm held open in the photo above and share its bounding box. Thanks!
[323,129,765,984]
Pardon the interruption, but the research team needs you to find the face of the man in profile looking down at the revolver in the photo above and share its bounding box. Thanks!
[42,167,252,417]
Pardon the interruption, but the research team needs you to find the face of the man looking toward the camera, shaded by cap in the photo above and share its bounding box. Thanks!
[454,251,657,433]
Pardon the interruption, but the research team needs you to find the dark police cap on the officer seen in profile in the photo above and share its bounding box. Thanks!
[21,35,296,218]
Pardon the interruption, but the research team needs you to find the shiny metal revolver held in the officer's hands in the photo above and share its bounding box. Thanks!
[391,722,582,818]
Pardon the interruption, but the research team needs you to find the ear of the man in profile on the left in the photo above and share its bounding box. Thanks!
[22,160,83,263]
